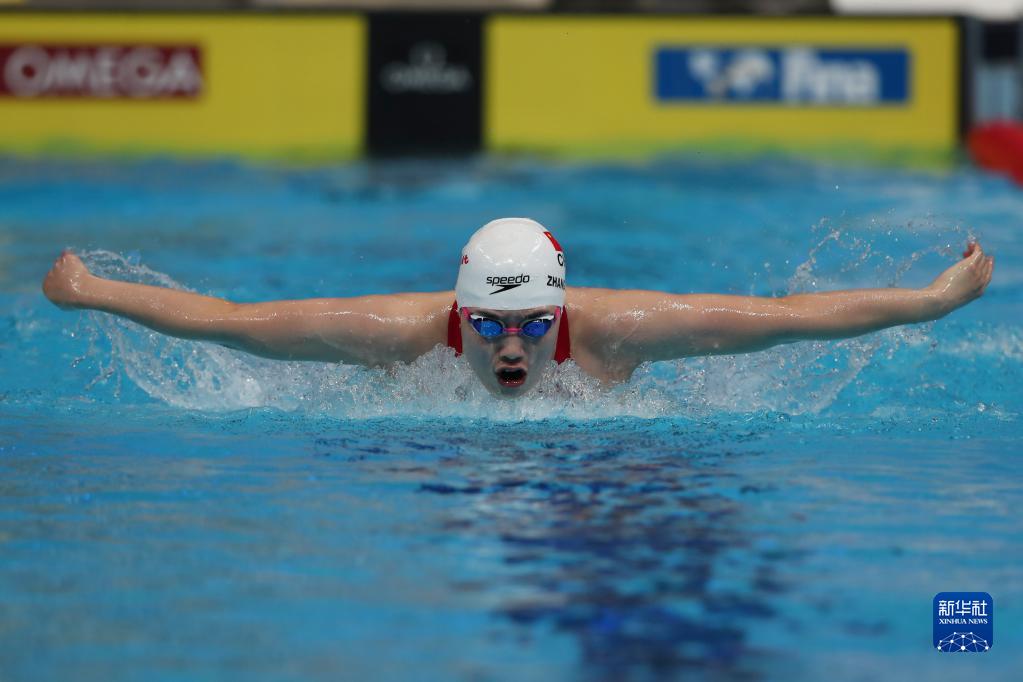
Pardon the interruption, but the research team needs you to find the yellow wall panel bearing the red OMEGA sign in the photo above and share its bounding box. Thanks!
[0,13,366,158]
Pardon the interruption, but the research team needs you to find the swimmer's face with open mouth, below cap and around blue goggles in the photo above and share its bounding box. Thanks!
[461,306,561,398]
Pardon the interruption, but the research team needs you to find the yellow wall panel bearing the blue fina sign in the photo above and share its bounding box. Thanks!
[484,15,959,158]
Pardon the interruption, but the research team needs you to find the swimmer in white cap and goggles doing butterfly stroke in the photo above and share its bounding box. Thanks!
[43,218,994,398]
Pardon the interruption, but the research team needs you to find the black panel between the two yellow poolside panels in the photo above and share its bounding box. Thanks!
[366,13,483,155]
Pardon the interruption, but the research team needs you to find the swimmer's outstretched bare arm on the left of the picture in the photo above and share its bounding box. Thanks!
[43,252,454,366]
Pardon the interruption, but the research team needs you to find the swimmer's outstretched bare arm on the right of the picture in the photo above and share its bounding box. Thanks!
[593,243,994,364]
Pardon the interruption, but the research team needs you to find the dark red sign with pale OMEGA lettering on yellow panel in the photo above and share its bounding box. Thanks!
[0,43,204,99]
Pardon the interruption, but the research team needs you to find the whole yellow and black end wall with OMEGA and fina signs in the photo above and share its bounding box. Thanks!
[0,11,961,158]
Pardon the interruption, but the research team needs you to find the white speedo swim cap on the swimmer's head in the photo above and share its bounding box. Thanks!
[454,218,565,310]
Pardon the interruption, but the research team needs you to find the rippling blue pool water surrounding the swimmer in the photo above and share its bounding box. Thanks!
[0,156,1023,681]
